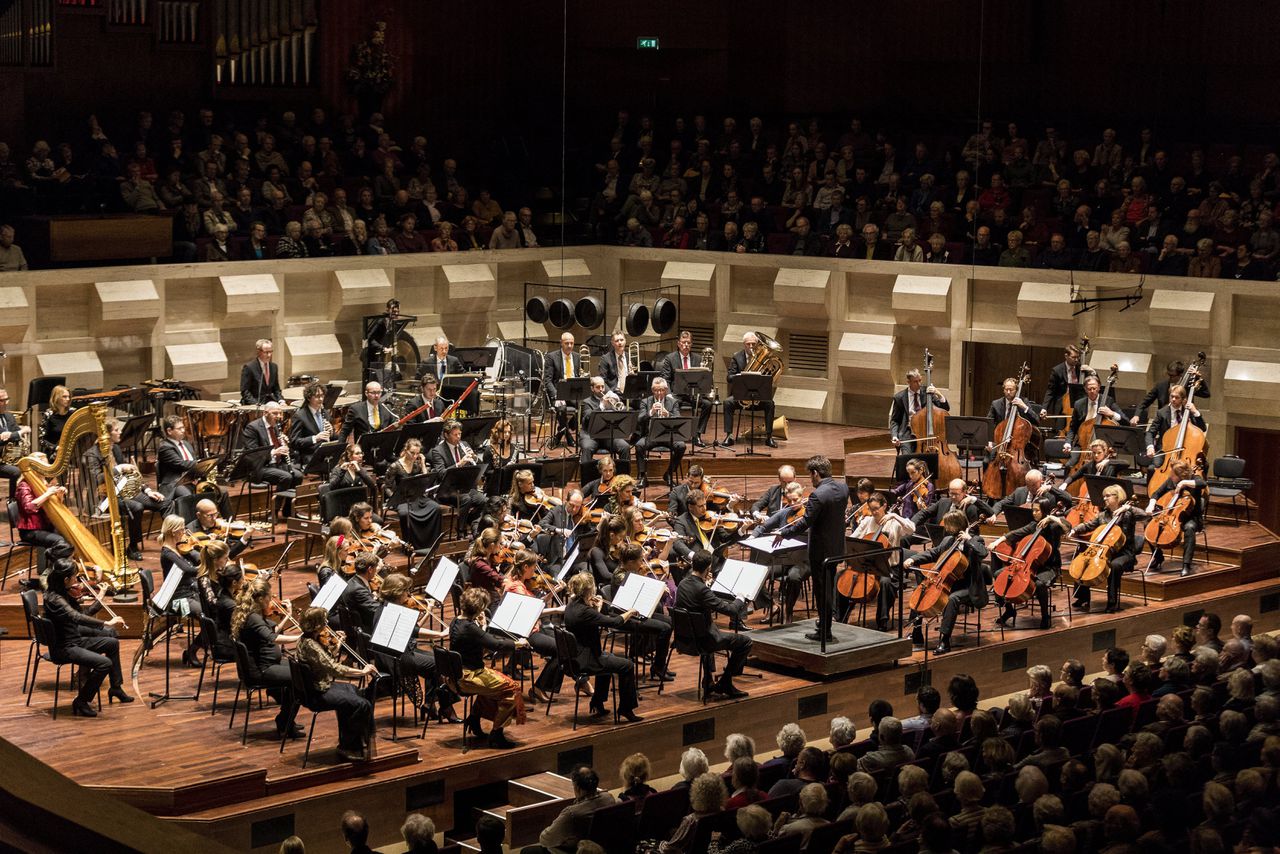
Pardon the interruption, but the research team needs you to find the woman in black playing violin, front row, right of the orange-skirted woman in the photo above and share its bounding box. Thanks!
[564,572,644,723]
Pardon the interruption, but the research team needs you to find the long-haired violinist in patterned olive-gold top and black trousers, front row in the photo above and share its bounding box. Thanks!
[298,608,378,762]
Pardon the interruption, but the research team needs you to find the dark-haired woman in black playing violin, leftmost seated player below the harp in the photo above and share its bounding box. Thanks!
[45,560,133,717]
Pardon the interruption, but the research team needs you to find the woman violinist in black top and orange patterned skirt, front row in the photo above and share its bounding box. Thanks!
[449,588,529,749]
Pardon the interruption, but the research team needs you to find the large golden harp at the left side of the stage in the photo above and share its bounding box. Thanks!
[18,403,138,592]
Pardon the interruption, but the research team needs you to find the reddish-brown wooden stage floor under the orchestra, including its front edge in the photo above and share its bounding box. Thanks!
[0,423,1280,851]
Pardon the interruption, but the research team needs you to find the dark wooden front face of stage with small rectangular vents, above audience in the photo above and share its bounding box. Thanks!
[160,584,1280,854]
